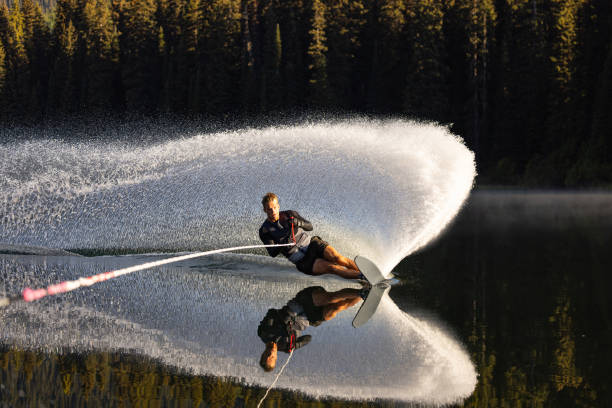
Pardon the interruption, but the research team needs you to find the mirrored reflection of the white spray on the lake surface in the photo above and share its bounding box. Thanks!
[0,255,477,404]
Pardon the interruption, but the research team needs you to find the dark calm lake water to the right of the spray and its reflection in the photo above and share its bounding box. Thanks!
[393,192,612,407]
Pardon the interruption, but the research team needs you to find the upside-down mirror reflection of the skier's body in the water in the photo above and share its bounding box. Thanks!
[257,286,367,371]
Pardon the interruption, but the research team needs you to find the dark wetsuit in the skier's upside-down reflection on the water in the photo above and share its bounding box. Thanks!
[257,286,325,353]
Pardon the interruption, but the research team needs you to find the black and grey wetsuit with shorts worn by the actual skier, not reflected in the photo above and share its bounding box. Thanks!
[259,210,329,275]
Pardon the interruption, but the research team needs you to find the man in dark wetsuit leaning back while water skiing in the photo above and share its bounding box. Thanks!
[259,193,365,279]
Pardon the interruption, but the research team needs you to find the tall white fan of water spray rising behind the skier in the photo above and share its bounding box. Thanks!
[0,119,475,271]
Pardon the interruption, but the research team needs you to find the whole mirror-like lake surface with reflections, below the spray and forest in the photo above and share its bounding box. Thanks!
[0,191,612,407]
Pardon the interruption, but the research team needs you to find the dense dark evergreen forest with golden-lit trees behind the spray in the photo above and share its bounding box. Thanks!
[0,0,612,186]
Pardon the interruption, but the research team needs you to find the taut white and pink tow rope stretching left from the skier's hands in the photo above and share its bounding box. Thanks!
[0,244,294,307]
